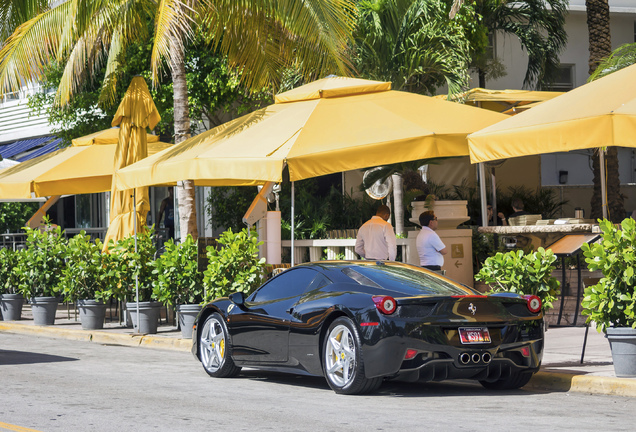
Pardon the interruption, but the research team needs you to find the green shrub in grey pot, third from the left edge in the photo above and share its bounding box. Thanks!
[60,235,115,330]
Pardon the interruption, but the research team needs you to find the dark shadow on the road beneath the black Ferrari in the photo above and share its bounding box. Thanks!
[237,369,540,398]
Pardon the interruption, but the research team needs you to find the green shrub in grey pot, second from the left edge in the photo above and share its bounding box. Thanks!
[14,224,66,325]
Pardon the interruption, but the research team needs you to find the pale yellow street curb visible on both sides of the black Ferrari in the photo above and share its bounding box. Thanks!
[0,321,636,397]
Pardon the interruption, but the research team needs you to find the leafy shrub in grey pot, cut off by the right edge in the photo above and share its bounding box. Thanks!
[581,218,636,377]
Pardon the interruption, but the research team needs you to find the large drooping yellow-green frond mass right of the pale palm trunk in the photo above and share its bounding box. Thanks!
[202,0,355,89]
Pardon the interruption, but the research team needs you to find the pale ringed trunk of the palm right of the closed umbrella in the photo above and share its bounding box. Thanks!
[170,37,199,241]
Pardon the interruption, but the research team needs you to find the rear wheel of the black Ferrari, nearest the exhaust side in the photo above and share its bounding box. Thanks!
[322,317,382,394]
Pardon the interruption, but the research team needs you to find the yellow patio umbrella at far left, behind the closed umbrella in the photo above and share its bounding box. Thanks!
[0,132,170,199]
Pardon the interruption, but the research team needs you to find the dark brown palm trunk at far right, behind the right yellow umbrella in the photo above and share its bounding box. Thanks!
[585,0,625,223]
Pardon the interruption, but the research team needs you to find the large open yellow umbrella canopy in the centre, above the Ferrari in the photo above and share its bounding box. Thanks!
[116,77,506,188]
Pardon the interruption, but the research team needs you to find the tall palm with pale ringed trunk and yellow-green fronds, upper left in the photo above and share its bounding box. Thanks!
[0,0,356,238]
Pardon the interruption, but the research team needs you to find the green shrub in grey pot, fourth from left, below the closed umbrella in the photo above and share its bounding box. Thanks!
[108,229,161,334]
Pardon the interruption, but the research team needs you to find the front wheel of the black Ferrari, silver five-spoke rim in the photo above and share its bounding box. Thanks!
[199,313,241,378]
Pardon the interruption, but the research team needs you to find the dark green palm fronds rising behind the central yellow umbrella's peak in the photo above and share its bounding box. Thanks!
[355,0,470,94]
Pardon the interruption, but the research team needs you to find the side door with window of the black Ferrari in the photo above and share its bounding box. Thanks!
[228,268,319,363]
